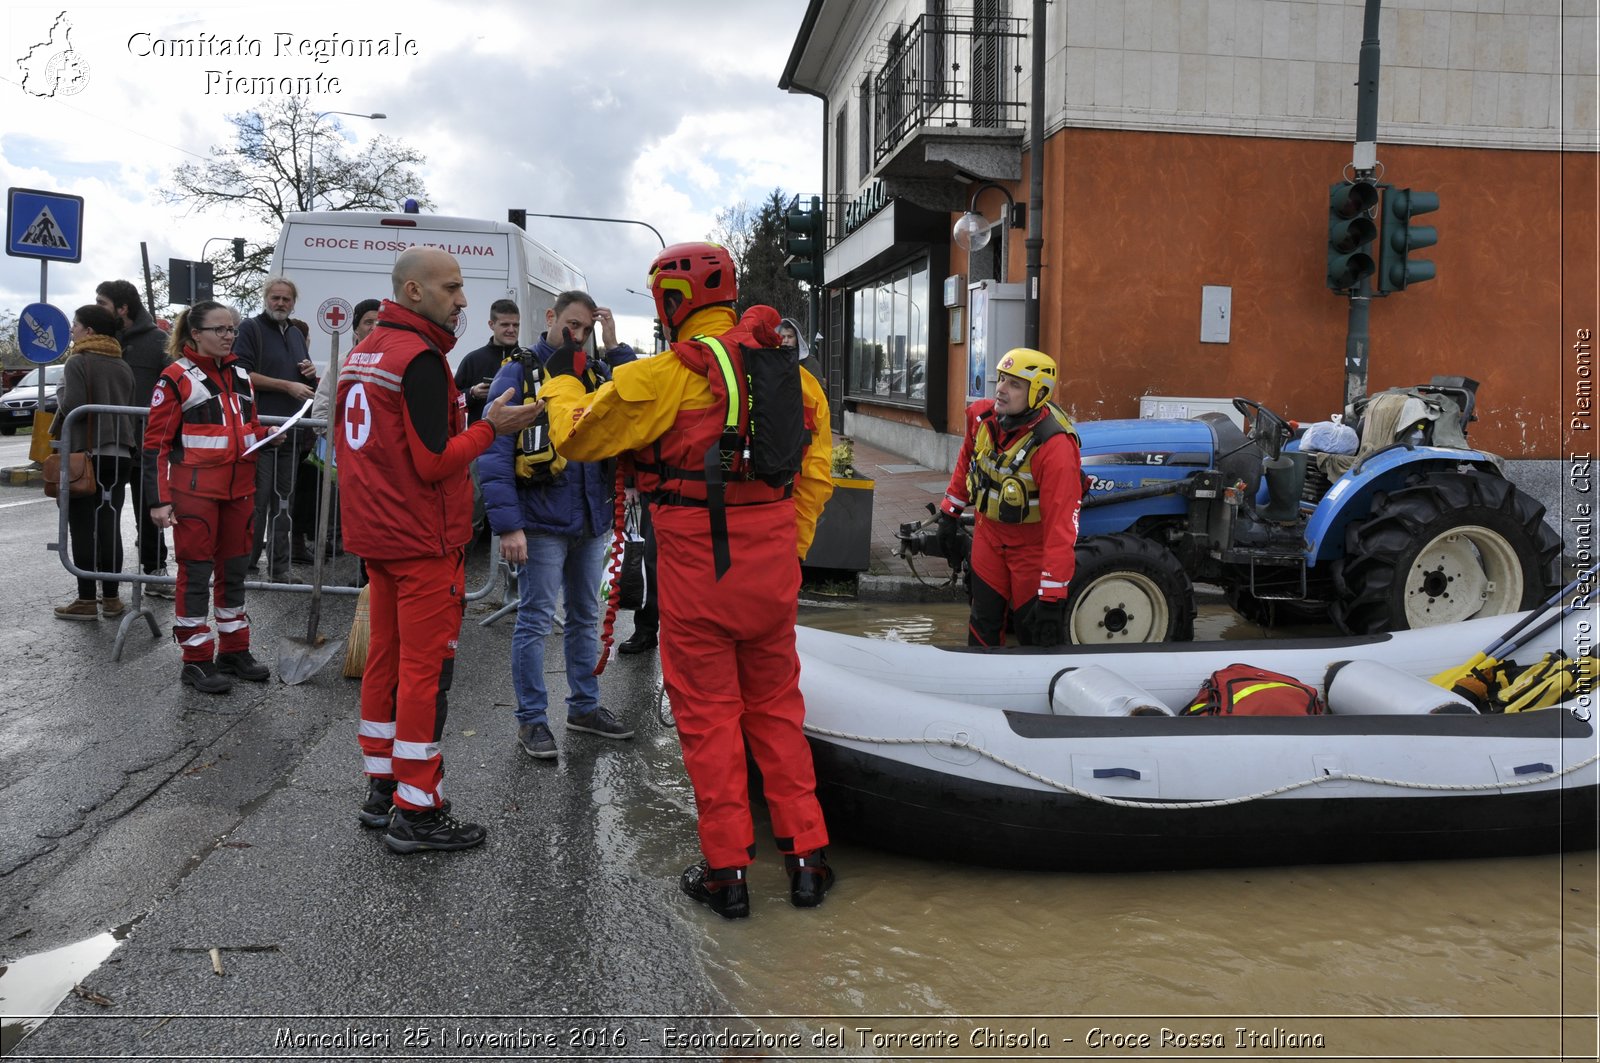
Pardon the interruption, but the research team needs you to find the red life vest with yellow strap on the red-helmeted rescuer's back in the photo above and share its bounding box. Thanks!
[634,336,816,578]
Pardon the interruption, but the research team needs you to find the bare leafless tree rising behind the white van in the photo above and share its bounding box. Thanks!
[162,96,432,307]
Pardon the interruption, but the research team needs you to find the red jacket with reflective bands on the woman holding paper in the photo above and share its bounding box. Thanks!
[155,357,262,496]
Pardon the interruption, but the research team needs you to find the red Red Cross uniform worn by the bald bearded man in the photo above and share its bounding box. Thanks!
[334,299,494,812]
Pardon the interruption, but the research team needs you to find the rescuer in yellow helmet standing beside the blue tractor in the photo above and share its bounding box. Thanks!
[939,347,1083,645]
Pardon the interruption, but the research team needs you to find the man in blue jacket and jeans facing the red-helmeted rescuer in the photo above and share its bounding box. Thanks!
[478,291,637,760]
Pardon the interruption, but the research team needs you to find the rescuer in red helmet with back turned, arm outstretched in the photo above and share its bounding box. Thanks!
[542,243,834,919]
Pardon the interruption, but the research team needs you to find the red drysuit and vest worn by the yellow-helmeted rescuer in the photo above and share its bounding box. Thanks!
[941,399,1083,645]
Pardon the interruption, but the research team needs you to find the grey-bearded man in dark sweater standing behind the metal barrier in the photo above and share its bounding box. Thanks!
[234,270,317,581]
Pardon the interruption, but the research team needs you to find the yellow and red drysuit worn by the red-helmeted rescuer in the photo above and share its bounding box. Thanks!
[541,306,834,868]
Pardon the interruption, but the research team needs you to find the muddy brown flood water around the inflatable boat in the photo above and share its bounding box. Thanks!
[681,604,1600,1060]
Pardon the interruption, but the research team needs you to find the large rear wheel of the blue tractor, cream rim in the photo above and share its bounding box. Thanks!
[1333,471,1562,634]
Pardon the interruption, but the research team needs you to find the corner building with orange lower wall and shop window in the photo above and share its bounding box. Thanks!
[781,0,1600,467]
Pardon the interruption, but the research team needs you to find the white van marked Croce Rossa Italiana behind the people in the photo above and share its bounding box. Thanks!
[272,210,587,371]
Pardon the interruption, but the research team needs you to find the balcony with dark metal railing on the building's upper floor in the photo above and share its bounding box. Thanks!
[872,14,1027,163]
